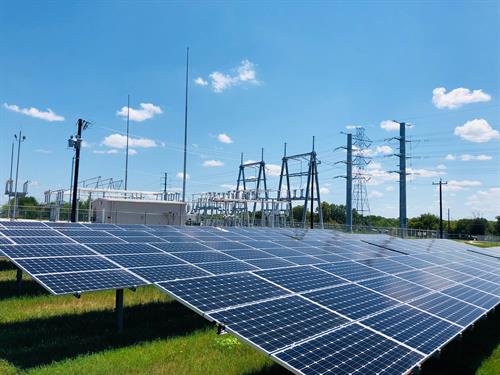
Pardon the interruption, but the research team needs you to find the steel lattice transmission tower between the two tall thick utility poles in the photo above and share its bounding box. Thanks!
[352,127,372,216]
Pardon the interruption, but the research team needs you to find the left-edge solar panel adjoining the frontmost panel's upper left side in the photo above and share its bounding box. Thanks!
[210,296,348,352]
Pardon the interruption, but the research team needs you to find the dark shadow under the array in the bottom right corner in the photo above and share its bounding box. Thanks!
[421,308,500,375]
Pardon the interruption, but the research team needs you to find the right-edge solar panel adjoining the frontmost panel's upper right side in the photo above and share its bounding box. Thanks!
[362,305,462,354]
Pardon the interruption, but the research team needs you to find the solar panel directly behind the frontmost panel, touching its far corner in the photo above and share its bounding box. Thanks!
[304,284,399,320]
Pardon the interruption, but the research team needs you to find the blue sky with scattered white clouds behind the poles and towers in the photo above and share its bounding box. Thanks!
[0,1,500,218]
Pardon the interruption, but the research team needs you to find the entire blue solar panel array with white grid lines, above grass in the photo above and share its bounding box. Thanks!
[0,222,500,374]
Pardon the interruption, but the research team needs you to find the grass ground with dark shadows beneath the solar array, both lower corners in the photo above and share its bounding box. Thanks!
[0,260,500,375]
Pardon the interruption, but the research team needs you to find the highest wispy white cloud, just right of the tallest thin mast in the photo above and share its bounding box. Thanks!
[201,60,260,93]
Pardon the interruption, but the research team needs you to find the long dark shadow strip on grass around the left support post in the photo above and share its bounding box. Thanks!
[0,302,209,369]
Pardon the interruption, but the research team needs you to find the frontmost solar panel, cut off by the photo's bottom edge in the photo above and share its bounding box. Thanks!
[275,323,423,375]
